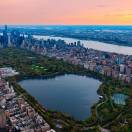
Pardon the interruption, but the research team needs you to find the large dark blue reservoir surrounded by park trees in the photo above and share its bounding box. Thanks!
[19,75,101,120]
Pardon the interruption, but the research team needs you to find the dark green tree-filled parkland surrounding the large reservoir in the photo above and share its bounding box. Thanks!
[0,48,132,132]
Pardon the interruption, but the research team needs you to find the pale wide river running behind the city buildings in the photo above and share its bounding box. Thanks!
[33,35,132,55]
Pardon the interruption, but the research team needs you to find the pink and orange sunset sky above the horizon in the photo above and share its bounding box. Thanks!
[0,0,132,25]
